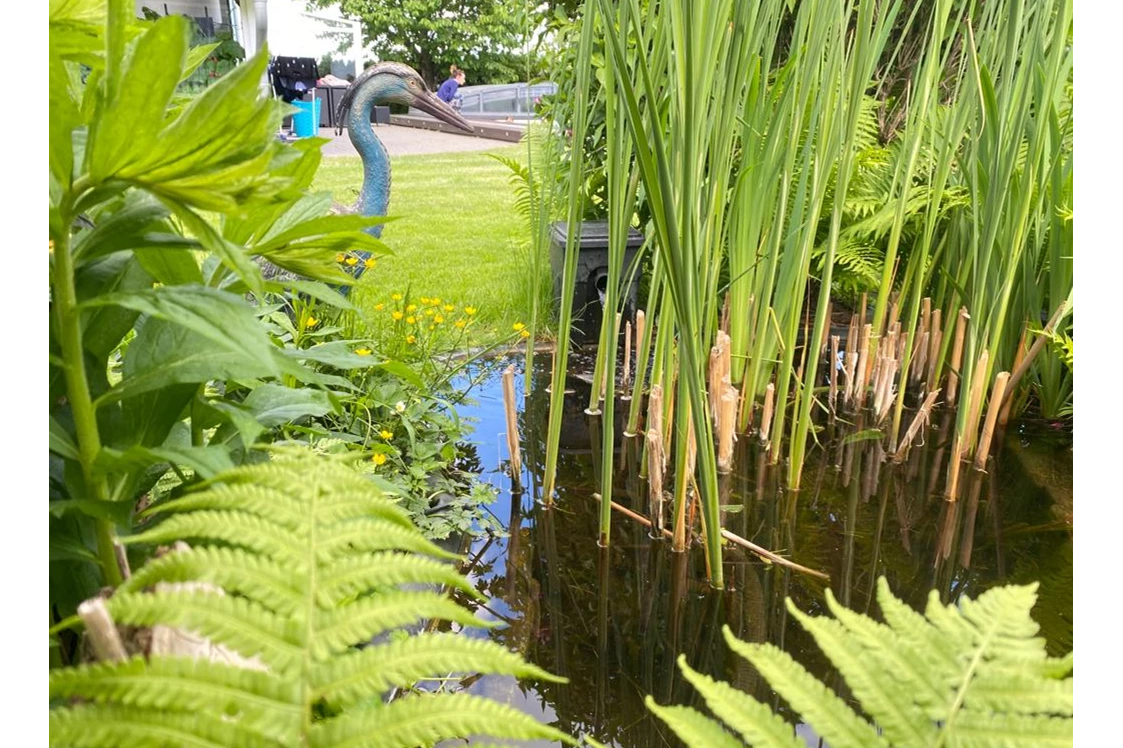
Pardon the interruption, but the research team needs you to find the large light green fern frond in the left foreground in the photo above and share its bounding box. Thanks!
[48,449,576,748]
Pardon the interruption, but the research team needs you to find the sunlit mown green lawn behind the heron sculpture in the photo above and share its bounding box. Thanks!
[312,146,528,338]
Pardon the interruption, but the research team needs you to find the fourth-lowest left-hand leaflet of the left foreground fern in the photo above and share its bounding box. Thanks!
[120,547,307,615]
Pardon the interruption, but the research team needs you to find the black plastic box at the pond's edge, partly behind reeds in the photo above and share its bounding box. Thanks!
[550,221,643,343]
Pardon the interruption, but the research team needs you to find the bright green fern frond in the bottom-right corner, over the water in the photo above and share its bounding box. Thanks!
[648,577,1072,748]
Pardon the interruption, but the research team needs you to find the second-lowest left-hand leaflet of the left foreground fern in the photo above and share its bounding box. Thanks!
[47,657,303,741]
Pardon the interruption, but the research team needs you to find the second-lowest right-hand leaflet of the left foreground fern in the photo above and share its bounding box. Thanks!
[312,633,566,709]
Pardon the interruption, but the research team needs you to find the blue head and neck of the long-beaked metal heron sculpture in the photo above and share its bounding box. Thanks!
[336,62,472,277]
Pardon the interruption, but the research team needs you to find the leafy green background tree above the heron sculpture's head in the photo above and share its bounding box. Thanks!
[310,0,537,85]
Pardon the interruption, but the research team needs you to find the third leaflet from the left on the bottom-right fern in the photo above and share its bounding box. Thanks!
[723,627,888,748]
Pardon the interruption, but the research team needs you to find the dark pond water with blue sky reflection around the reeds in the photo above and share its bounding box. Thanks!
[433,356,1072,747]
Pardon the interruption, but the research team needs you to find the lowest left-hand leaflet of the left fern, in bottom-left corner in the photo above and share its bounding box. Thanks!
[47,704,276,748]
